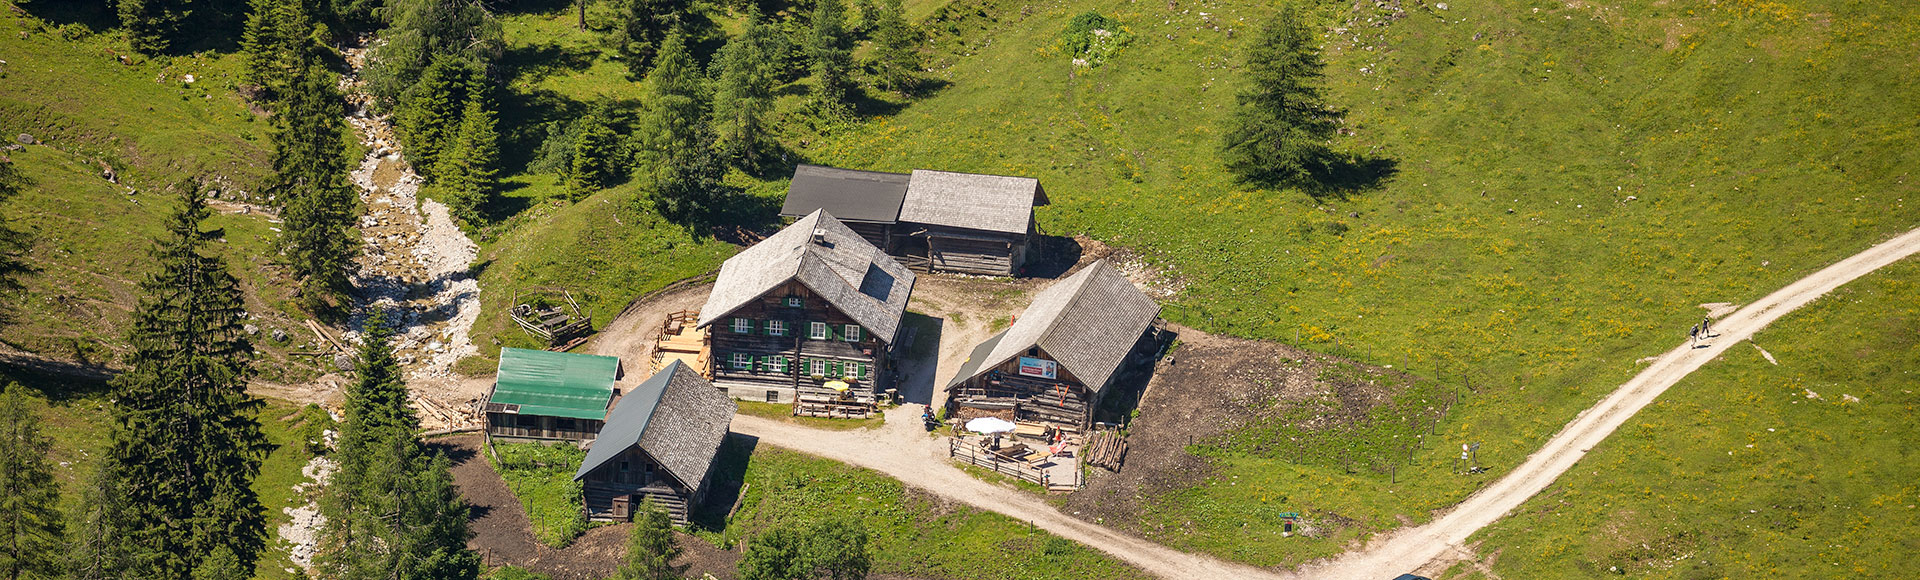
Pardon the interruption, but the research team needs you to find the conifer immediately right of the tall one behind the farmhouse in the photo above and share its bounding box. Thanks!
[714,4,787,171]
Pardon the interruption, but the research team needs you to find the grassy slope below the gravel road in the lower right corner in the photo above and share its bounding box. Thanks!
[1451,259,1920,578]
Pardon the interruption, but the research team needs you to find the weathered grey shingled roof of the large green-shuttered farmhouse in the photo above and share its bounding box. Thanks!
[699,209,914,344]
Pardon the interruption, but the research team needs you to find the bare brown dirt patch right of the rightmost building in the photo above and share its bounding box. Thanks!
[1066,325,1402,532]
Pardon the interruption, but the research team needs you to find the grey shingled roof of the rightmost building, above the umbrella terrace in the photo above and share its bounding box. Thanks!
[948,259,1160,392]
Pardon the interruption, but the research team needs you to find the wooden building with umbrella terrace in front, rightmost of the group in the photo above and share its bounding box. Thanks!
[947,259,1160,430]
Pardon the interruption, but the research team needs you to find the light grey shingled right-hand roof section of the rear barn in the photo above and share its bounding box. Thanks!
[900,169,1046,234]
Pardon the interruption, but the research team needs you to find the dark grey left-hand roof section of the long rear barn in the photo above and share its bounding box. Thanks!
[780,165,908,223]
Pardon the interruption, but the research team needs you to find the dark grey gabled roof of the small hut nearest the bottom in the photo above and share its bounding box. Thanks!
[574,361,735,488]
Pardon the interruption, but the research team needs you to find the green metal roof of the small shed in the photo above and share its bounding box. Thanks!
[488,348,620,419]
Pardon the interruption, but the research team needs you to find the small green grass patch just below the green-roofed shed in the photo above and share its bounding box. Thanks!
[488,444,588,547]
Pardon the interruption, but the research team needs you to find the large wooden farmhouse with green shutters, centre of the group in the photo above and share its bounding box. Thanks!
[697,209,914,417]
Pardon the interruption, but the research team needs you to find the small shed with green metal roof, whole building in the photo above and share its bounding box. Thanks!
[486,348,620,442]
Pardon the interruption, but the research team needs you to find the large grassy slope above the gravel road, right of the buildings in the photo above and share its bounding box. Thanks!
[775,2,1920,565]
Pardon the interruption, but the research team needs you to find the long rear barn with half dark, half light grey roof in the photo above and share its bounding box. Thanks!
[780,165,1046,277]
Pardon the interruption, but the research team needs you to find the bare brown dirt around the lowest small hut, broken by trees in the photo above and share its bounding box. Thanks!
[428,434,739,580]
